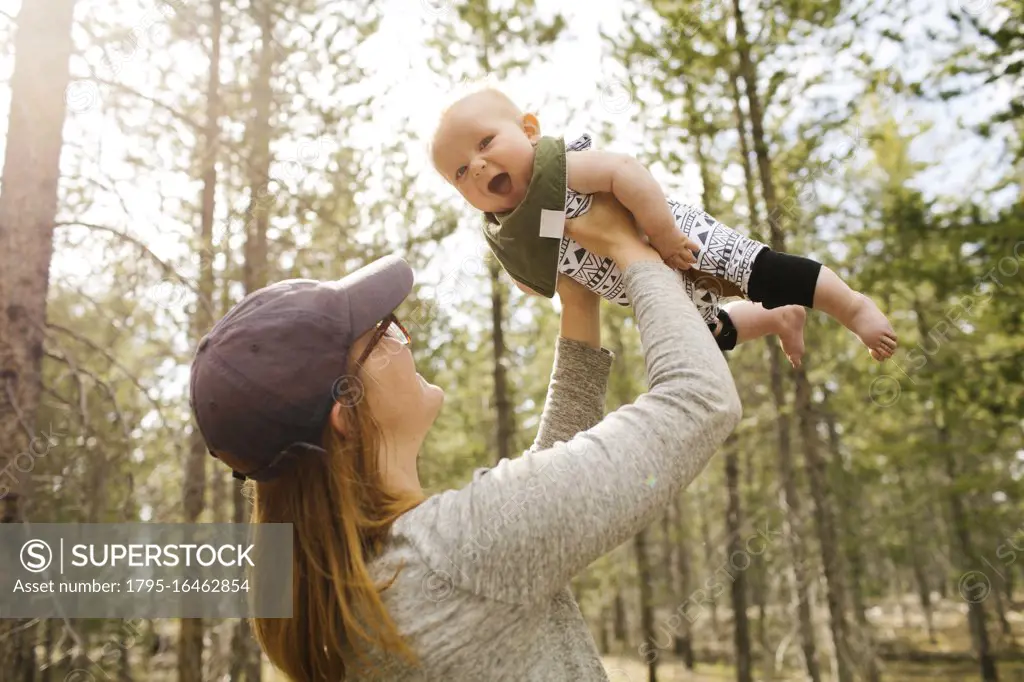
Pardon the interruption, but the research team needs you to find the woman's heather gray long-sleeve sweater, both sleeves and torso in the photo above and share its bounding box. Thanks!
[359,262,740,682]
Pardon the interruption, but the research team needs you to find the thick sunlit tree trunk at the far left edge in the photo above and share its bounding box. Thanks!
[0,0,75,667]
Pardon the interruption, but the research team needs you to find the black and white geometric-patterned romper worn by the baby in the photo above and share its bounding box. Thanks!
[558,135,767,327]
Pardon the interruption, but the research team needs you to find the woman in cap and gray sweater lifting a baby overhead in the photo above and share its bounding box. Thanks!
[191,214,740,682]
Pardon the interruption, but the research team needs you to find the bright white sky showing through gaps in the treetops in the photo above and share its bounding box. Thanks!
[0,0,1011,313]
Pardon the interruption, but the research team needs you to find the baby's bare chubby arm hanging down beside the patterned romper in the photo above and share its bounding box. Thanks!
[565,151,698,269]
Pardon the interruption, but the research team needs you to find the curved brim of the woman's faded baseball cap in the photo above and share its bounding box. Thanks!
[330,255,415,338]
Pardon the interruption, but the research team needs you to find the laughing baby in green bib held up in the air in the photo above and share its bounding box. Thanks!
[432,89,897,367]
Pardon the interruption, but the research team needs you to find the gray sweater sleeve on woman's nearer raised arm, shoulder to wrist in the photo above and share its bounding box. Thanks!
[411,224,740,603]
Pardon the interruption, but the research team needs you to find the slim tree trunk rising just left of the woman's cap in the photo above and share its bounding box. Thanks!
[178,0,221,682]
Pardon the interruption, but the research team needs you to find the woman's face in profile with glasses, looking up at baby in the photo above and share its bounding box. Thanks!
[350,315,444,448]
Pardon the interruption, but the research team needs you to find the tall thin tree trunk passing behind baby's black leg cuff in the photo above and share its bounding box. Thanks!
[732,0,821,682]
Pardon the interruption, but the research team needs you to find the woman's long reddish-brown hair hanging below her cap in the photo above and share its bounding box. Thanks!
[252,382,424,682]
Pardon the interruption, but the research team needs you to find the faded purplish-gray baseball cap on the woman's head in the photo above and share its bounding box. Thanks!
[189,251,414,480]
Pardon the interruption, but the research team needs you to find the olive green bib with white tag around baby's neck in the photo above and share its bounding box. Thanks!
[483,137,566,298]
